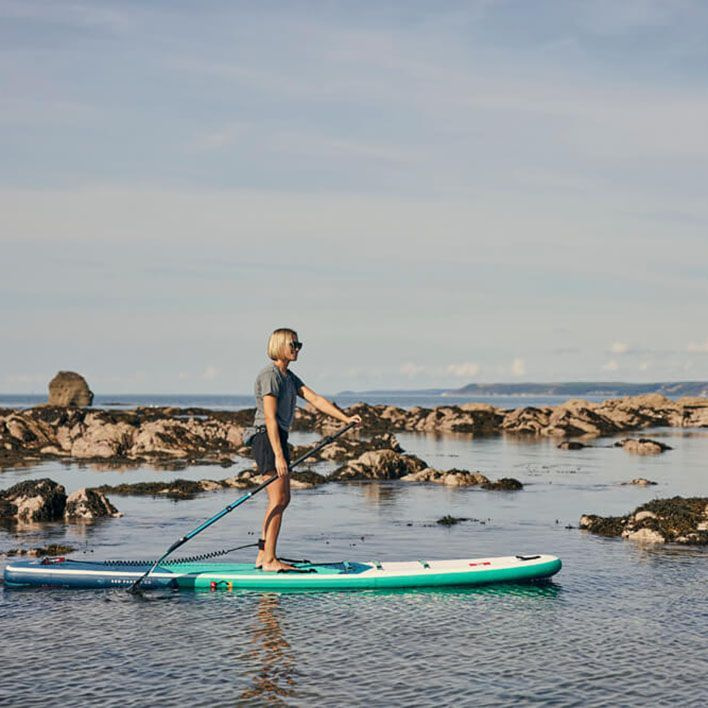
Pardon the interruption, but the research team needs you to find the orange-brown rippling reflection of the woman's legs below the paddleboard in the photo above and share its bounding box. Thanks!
[237,593,295,703]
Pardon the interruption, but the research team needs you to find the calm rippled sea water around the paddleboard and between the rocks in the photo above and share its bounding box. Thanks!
[0,401,708,706]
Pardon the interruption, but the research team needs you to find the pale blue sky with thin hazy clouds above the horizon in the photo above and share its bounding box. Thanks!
[0,0,708,393]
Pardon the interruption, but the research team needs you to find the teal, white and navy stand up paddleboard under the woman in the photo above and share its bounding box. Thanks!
[4,555,561,591]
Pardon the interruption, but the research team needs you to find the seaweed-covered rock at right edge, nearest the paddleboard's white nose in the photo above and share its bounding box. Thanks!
[579,497,708,545]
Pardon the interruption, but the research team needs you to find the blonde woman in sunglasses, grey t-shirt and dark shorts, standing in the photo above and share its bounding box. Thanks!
[252,328,361,571]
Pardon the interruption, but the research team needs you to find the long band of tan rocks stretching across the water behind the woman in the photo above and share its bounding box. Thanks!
[0,394,708,466]
